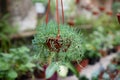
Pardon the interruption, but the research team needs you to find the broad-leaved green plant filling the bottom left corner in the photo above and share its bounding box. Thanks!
[0,47,36,80]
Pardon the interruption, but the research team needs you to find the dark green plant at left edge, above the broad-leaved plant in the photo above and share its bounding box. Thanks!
[0,14,16,52]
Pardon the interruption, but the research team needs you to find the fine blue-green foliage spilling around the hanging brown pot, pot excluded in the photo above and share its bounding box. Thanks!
[33,21,83,64]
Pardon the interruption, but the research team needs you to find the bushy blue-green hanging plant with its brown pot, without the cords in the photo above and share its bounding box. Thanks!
[33,21,83,64]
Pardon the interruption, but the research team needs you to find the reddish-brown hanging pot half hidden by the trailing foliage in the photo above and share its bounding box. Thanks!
[46,38,71,53]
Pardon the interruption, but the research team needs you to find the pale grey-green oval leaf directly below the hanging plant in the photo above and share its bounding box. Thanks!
[45,63,58,79]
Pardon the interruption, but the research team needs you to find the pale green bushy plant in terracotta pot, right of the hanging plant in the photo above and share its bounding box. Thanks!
[90,27,107,56]
